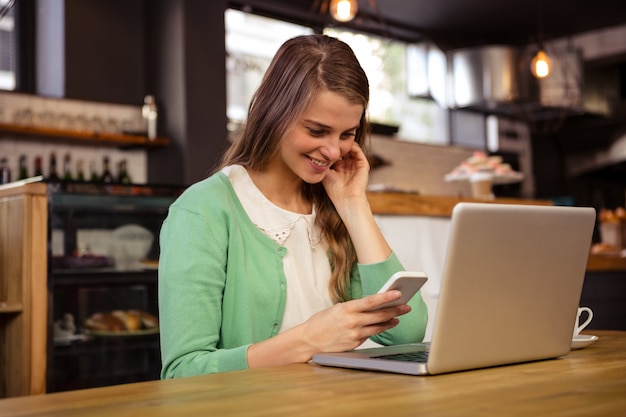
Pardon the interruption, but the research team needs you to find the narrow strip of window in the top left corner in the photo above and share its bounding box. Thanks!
[0,0,16,90]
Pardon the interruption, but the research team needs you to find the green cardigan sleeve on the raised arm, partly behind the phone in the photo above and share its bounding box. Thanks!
[351,252,428,345]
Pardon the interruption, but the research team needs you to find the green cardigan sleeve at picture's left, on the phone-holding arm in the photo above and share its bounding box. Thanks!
[159,203,249,378]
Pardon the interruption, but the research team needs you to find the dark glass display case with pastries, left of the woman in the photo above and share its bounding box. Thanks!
[47,183,182,392]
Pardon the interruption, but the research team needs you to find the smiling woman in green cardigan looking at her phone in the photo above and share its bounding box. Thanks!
[159,35,427,378]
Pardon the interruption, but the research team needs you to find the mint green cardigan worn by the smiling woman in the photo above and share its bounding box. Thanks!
[158,173,428,378]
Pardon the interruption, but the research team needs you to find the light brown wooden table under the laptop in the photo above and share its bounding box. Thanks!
[0,331,626,417]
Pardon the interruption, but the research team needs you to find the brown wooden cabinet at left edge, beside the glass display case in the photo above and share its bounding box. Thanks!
[0,183,48,394]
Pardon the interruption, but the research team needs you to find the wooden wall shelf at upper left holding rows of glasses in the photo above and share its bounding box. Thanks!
[0,123,170,148]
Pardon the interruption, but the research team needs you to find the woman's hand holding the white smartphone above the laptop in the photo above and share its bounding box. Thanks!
[302,291,411,354]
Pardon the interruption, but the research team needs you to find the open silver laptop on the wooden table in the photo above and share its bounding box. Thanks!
[312,202,596,375]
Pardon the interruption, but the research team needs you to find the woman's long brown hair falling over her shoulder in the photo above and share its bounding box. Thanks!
[220,35,369,302]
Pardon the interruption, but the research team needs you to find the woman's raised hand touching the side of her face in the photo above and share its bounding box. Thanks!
[322,142,370,205]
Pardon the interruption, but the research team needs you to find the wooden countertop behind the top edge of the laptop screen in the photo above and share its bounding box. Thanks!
[367,192,552,217]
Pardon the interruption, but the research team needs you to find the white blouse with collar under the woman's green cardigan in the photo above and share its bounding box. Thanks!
[222,165,333,332]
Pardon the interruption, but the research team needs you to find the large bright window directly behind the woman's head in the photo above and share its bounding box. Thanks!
[225,9,449,145]
